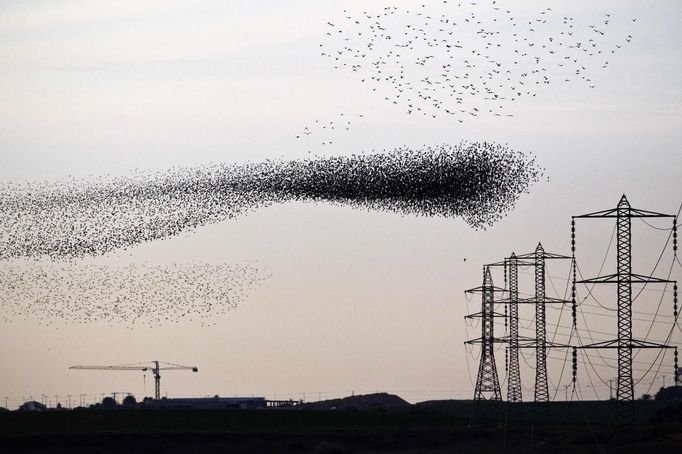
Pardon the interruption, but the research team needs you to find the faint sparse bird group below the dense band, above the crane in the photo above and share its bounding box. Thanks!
[0,260,267,328]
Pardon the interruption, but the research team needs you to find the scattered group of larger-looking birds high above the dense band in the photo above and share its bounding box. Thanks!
[320,0,635,122]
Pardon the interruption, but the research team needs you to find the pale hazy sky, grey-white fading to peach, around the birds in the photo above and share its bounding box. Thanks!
[0,0,682,406]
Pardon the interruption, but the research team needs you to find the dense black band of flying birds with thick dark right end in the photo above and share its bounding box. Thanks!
[0,142,542,259]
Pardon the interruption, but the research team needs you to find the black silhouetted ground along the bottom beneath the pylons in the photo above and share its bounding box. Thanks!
[0,401,682,454]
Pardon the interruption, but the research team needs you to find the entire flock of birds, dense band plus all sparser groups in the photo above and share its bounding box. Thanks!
[0,0,572,326]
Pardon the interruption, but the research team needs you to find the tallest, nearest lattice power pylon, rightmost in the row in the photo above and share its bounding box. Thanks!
[571,195,677,404]
